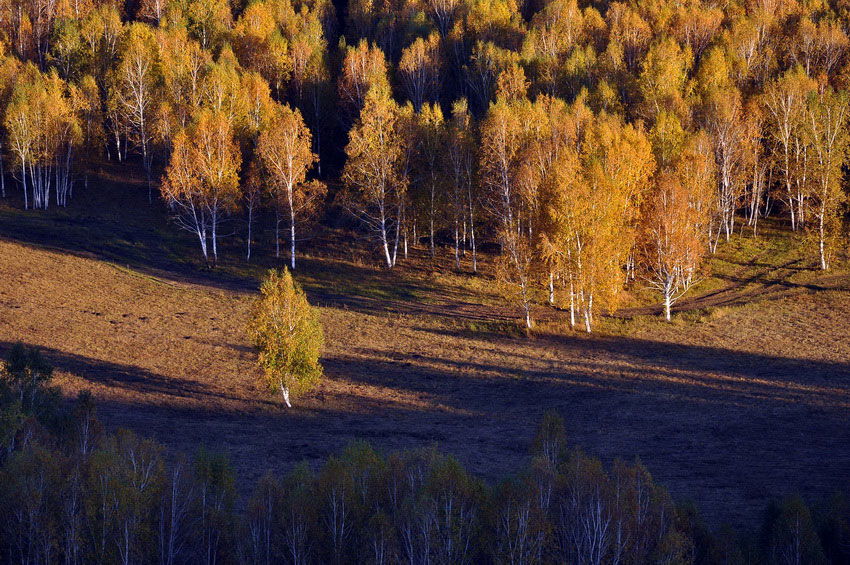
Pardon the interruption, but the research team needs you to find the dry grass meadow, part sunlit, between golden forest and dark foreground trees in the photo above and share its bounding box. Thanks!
[0,165,850,525]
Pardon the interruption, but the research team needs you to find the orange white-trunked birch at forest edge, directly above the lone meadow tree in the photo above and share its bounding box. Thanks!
[257,105,327,269]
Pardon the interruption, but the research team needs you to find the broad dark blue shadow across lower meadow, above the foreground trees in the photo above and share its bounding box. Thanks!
[0,337,850,524]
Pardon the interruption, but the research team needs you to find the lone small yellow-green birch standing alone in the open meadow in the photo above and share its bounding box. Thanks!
[248,269,324,408]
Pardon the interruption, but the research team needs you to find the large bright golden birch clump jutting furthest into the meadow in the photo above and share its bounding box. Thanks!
[541,107,655,332]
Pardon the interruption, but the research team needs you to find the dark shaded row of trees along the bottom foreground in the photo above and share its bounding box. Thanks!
[0,345,850,564]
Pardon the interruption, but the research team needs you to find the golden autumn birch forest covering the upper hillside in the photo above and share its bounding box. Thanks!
[0,0,850,331]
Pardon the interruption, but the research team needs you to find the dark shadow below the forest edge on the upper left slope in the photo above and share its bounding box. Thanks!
[0,180,464,313]
